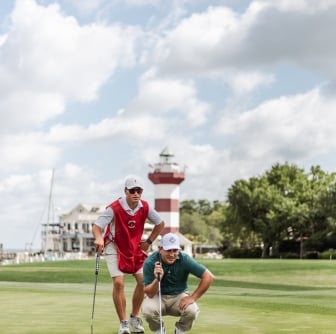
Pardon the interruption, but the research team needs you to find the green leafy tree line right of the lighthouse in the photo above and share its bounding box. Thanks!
[180,163,336,258]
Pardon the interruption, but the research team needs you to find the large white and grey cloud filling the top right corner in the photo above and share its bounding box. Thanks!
[148,1,336,90]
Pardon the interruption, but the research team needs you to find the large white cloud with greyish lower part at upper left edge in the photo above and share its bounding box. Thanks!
[0,0,140,136]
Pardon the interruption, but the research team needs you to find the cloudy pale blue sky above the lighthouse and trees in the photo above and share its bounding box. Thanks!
[0,0,336,250]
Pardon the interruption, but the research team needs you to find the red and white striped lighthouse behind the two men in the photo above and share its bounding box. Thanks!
[148,148,185,235]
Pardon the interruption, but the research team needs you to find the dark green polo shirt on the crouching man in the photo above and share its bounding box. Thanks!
[143,251,206,295]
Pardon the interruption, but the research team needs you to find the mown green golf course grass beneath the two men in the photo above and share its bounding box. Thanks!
[0,260,336,334]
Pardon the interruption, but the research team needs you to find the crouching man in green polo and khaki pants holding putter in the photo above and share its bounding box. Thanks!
[142,233,214,334]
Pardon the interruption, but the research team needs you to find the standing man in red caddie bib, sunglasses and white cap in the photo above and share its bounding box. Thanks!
[92,176,164,334]
